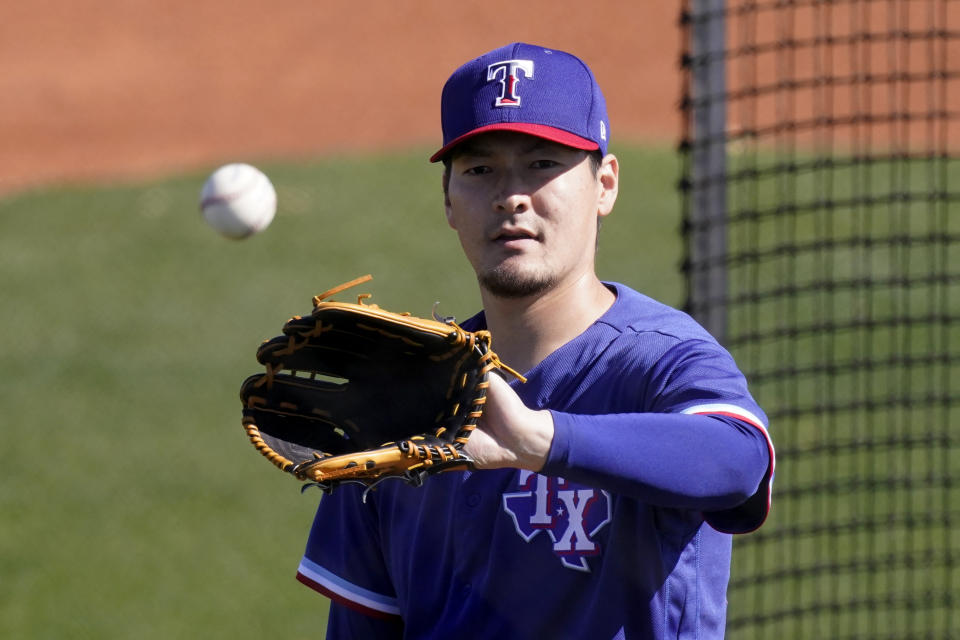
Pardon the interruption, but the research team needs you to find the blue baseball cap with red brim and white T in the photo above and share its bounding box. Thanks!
[430,42,610,162]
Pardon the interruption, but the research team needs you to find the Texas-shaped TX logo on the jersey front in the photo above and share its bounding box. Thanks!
[503,470,610,571]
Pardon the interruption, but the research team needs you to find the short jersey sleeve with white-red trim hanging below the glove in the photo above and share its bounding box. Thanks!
[297,486,400,624]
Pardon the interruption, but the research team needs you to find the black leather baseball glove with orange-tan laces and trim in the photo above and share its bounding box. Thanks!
[240,276,523,495]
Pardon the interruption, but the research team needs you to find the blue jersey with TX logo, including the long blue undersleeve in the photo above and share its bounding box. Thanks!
[298,284,774,640]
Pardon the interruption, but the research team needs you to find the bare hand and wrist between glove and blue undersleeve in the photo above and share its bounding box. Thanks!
[464,374,553,471]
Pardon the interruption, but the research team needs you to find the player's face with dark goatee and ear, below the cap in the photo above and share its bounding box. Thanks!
[445,132,617,298]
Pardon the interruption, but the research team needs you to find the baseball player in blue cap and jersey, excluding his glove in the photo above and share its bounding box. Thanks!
[298,43,774,640]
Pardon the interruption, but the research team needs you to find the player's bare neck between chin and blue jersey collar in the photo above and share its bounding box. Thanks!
[481,273,615,372]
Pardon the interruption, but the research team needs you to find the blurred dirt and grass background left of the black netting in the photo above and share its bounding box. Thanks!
[0,0,683,638]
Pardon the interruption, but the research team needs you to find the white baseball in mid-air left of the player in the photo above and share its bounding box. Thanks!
[200,162,277,239]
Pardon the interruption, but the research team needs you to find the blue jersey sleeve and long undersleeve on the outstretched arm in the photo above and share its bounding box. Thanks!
[543,340,774,533]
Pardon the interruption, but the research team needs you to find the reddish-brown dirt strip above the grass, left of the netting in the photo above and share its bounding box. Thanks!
[0,0,680,192]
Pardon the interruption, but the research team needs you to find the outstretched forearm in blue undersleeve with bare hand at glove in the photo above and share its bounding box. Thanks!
[466,376,770,510]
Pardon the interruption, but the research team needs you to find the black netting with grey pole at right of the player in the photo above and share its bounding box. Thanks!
[681,0,960,639]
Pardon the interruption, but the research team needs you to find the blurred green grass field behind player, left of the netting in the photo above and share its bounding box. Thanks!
[0,149,683,639]
